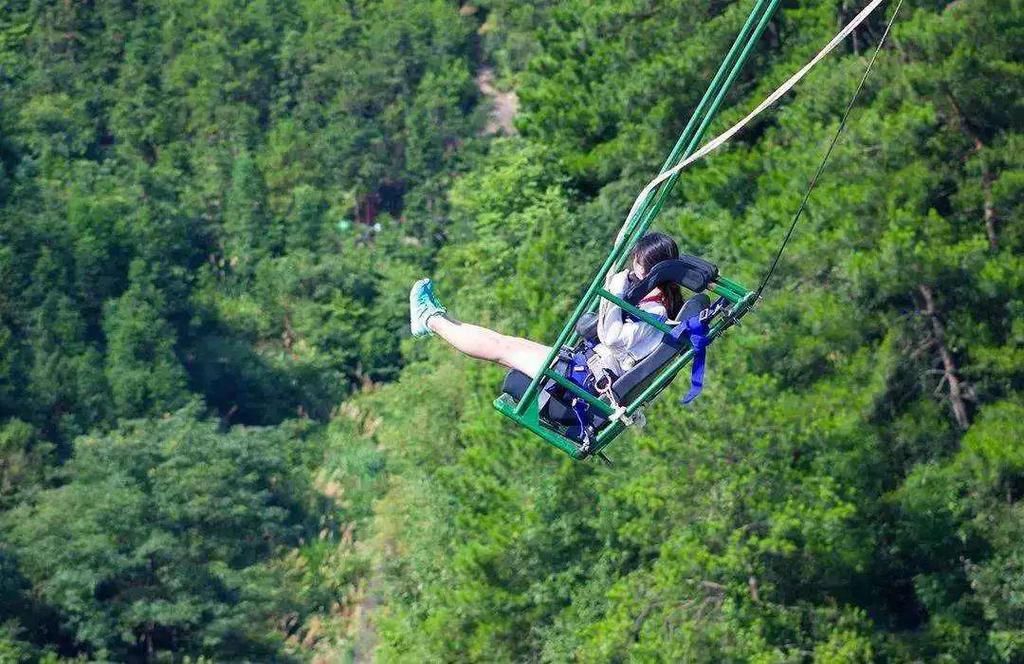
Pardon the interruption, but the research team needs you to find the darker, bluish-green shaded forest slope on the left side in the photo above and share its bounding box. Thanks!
[0,0,482,660]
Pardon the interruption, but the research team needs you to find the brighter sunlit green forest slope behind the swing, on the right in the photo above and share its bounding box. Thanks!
[366,3,1022,662]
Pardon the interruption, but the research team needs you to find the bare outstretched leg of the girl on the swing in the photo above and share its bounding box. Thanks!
[427,314,551,377]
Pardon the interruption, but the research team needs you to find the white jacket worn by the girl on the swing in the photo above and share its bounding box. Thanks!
[595,269,668,376]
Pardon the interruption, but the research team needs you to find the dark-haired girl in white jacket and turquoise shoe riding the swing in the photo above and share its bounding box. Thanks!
[409,233,683,377]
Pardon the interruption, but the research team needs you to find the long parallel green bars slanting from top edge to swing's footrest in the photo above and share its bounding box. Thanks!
[507,0,779,426]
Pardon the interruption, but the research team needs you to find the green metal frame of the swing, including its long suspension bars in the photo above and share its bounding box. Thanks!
[495,0,780,459]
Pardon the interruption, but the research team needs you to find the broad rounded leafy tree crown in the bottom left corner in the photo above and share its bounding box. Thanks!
[4,406,310,659]
